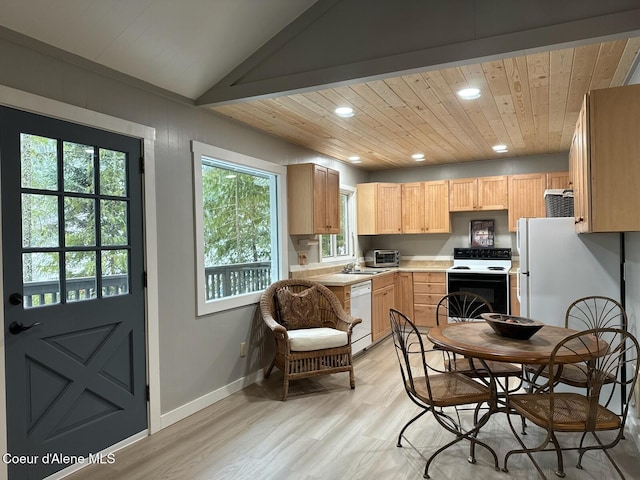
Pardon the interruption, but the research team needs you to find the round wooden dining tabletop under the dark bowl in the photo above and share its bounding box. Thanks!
[427,322,607,365]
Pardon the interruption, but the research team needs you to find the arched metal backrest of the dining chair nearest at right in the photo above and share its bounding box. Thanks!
[549,328,640,431]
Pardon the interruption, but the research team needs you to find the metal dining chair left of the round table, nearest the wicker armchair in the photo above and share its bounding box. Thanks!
[389,309,499,478]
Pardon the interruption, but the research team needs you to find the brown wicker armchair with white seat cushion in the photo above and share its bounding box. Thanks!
[260,279,362,401]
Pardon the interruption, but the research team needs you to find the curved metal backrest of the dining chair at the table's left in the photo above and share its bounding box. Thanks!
[389,308,431,397]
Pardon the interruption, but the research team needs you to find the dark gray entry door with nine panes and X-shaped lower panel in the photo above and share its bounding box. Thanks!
[0,108,147,479]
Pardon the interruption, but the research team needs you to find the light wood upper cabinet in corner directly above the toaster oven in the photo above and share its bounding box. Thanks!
[356,183,402,235]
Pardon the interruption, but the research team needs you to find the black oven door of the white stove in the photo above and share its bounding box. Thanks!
[447,272,509,314]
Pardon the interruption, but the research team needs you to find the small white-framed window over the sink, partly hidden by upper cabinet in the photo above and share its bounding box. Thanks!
[320,187,355,262]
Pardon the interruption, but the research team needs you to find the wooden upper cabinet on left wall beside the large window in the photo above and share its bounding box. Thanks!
[287,163,340,235]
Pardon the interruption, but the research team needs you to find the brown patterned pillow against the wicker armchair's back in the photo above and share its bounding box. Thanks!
[276,286,322,330]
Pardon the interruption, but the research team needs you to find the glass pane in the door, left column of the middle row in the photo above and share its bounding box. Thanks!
[22,193,60,248]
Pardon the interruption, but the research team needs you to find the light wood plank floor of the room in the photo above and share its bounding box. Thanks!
[68,338,640,480]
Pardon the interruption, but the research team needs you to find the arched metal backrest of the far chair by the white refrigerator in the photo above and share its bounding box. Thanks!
[564,295,627,330]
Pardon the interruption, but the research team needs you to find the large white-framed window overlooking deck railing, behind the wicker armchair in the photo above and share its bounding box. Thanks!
[192,141,286,315]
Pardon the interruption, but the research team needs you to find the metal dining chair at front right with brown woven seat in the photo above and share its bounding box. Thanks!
[503,328,640,480]
